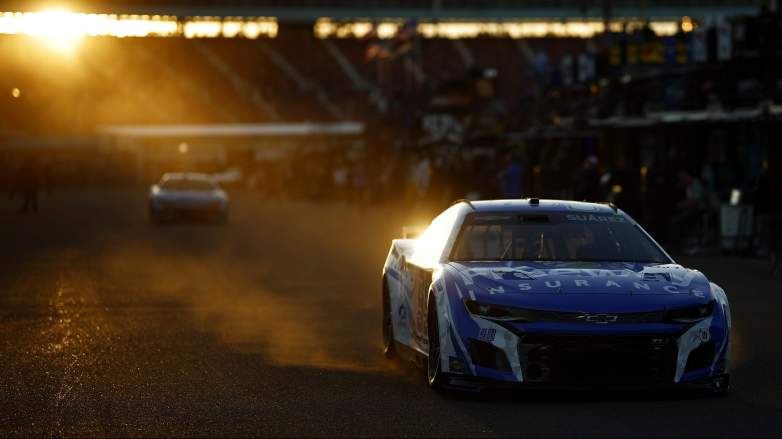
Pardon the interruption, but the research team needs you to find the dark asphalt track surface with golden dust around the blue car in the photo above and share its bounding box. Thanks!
[0,189,782,437]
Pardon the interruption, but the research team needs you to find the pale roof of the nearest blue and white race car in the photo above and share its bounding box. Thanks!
[463,198,621,213]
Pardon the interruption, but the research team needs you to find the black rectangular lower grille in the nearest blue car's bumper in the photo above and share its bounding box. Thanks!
[519,334,676,384]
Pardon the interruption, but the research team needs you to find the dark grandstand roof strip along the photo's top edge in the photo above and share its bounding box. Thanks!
[4,0,764,18]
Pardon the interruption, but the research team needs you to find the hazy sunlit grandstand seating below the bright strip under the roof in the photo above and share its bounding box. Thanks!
[0,24,776,133]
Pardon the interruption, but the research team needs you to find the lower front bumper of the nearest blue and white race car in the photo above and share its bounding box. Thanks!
[443,318,729,388]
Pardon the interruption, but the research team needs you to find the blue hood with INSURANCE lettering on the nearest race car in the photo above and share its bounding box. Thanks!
[445,261,711,312]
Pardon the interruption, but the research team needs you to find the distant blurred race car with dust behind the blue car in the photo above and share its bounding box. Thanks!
[149,173,229,223]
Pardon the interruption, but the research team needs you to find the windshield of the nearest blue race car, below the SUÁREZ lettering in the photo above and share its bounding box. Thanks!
[451,213,670,263]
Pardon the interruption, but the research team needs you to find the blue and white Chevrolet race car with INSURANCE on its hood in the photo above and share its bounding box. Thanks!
[382,198,731,394]
